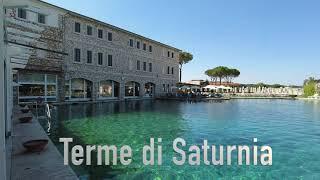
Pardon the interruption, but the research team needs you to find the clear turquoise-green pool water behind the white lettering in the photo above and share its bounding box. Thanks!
[42,100,320,179]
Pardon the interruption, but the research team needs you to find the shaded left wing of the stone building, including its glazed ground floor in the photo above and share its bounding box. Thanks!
[5,0,67,103]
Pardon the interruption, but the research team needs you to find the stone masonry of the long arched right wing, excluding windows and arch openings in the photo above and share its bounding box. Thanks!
[64,15,179,100]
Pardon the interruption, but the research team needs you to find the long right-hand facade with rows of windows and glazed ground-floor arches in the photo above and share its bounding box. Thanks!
[64,13,180,101]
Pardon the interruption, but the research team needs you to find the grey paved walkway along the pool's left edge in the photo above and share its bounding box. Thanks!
[11,107,78,180]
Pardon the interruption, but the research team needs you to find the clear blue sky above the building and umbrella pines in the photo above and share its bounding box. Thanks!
[46,0,320,85]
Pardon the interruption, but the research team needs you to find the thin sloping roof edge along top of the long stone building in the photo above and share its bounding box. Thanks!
[37,0,182,51]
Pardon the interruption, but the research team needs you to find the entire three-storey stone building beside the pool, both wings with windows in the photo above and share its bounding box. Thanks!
[5,0,180,103]
